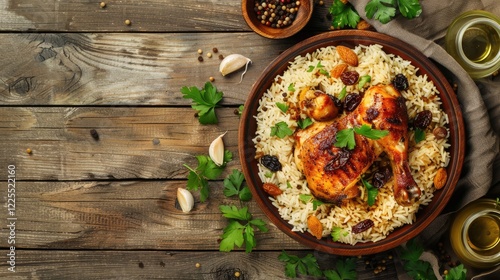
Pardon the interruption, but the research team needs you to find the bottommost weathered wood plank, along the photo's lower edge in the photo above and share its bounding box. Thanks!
[0,250,397,280]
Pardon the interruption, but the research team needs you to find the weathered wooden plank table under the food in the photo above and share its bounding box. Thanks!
[0,0,448,279]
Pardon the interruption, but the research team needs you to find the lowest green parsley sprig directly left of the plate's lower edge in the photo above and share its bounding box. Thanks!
[219,205,268,253]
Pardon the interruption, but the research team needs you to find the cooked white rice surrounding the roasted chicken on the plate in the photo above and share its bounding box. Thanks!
[253,45,449,245]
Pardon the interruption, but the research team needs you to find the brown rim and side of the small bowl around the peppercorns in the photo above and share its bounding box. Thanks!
[241,0,314,39]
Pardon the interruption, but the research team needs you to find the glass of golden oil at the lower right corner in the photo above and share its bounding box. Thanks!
[450,199,500,268]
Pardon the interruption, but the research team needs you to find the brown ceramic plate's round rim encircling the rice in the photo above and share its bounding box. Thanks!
[238,30,465,256]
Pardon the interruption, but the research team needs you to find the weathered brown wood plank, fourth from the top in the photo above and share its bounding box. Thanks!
[0,180,304,250]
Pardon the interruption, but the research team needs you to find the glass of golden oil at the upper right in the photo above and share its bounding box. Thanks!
[445,10,500,79]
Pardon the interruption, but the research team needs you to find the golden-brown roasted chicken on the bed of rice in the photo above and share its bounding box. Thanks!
[295,85,420,205]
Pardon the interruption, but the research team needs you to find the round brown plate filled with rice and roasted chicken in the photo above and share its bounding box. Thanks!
[238,30,466,256]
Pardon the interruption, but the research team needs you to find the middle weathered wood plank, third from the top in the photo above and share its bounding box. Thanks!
[0,107,240,180]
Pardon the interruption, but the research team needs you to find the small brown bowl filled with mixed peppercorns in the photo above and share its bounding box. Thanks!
[241,0,313,39]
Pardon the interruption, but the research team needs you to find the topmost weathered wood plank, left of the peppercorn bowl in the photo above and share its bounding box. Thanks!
[0,0,331,32]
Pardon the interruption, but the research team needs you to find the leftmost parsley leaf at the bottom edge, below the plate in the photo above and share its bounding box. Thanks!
[278,250,323,278]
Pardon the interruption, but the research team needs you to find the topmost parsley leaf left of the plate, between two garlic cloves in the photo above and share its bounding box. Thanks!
[181,82,223,124]
